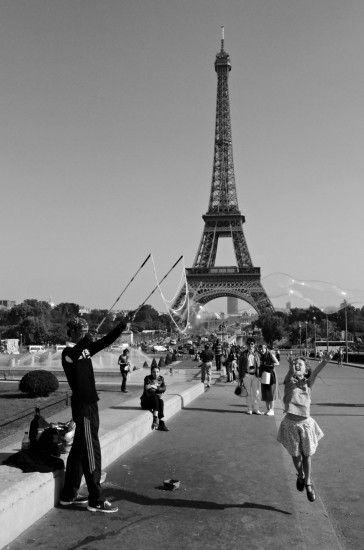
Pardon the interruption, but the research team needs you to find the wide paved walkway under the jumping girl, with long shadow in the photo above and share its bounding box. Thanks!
[2,360,364,550]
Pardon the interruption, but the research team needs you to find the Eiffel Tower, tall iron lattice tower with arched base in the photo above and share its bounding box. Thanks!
[174,27,274,314]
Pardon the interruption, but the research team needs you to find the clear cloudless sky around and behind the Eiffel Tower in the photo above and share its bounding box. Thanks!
[0,0,364,311]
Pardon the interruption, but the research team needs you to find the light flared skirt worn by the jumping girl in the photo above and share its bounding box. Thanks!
[277,417,324,456]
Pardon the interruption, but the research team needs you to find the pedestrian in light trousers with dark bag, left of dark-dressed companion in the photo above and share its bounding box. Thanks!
[239,337,262,414]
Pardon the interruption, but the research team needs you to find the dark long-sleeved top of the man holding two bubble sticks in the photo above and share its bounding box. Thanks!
[62,322,126,412]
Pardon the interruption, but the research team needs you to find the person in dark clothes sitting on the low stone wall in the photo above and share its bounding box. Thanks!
[140,366,169,432]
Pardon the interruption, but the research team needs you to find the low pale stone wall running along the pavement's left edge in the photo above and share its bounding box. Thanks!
[0,384,204,548]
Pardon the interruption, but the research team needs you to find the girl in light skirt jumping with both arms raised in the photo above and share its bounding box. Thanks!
[277,352,333,502]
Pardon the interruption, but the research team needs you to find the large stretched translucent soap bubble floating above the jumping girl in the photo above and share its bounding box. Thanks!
[262,273,364,315]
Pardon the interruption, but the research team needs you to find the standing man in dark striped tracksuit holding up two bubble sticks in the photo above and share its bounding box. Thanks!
[60,318,126,513]
